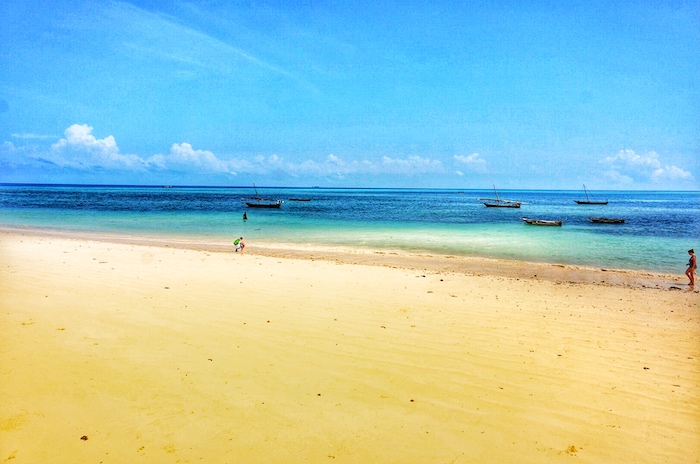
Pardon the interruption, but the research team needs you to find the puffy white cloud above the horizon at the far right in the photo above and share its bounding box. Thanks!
[601,150,693,184]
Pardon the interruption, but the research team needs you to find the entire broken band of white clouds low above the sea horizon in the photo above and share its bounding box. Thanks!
[0,124,694,186]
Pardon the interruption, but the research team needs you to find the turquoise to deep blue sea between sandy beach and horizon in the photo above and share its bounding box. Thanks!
[0,185,700,274]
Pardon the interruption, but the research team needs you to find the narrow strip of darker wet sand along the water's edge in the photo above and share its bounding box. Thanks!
[0,227,688,291]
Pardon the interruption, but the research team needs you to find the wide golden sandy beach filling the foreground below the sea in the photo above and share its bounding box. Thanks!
[0,231,700,464]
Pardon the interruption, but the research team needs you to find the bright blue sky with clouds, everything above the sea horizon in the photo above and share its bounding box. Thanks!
[0,0,700,190]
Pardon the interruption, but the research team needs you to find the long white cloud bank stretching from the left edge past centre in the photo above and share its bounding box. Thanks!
[0,124,464,178]
